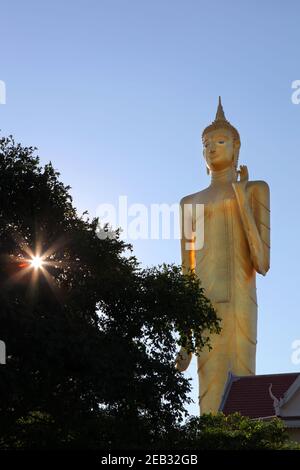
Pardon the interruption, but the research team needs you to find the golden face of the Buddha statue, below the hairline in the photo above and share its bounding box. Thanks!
[203,129,238,171]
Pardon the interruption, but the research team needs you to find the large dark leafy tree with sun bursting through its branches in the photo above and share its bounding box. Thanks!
[0,137,220,449]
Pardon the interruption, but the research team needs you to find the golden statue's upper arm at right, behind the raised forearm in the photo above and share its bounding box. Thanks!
[233,181,270,275]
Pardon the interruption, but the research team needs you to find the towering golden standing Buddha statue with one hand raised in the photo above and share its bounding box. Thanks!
[176,98,270,414]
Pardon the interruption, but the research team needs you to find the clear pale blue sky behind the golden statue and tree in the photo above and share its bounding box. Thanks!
[0,0,300,412]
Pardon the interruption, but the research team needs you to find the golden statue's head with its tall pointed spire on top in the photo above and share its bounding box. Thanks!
[202,97,241,173]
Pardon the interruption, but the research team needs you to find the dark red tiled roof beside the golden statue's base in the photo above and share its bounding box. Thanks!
[222,372,300,418]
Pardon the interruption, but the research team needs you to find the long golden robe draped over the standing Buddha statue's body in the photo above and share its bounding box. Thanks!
[182,181,270,414]
